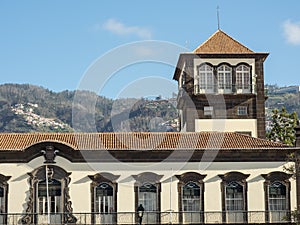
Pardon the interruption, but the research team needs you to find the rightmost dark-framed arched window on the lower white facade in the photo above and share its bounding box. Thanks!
[262,171,292,223]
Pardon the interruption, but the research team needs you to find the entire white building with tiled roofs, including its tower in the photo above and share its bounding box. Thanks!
[0,30,300,224]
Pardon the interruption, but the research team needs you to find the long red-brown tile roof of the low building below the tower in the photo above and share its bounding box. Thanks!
[0,132,288,151]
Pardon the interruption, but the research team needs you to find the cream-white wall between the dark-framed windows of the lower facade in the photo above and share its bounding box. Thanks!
[0,157,296,213]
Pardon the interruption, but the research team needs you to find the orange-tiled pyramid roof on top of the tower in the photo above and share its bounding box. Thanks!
[193,30,254,54]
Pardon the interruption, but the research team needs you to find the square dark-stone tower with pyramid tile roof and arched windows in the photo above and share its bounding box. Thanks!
[173,29,268,138]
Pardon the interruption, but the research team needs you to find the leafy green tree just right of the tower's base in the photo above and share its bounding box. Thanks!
[267,107,298,146]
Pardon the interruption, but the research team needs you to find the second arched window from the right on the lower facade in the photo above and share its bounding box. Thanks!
[219,172,249,223]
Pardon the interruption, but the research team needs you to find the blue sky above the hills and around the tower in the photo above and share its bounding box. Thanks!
[0,0,300,98]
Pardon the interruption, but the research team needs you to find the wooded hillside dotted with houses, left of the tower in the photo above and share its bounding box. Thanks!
[0,84,178,132]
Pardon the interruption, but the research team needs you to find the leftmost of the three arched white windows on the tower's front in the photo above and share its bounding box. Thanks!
[195,64,214,94]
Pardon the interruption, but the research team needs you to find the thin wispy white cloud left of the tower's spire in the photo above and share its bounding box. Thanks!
[103,19,152,39]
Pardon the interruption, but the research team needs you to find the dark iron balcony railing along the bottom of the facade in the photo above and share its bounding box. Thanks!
[4,211,296,225]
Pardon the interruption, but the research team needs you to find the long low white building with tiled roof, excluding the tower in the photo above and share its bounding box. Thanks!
[0,132,297,224]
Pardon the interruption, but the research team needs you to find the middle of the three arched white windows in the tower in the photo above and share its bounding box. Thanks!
[218,65,232,93]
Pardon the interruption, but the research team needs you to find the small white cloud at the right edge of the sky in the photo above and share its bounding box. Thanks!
[283,20,300,45]
